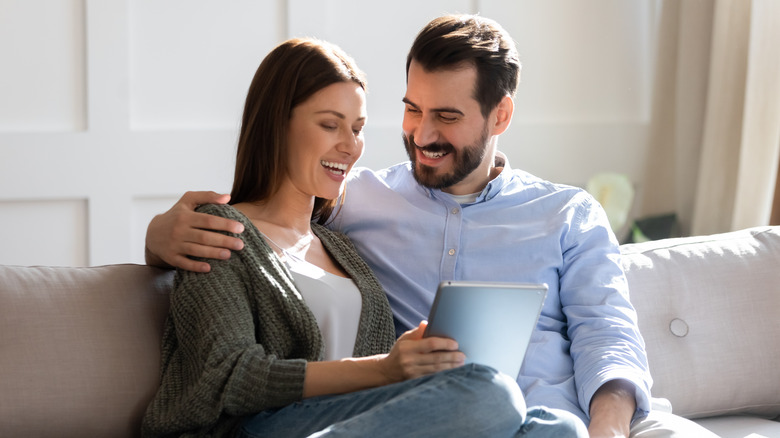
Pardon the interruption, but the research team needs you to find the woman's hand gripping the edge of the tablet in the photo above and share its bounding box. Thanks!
[379,321,466,383]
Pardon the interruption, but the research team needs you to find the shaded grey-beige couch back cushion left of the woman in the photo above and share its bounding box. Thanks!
[0,265,173,437]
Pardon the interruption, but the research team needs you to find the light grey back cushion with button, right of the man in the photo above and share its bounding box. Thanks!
[621,227,780,418]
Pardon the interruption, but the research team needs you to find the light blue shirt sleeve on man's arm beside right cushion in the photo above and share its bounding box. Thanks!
[560,194,652,417]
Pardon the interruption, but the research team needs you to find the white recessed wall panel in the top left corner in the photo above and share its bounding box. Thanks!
[0,0,86,132]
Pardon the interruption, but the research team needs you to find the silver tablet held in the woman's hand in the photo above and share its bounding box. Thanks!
[423,281,547,378]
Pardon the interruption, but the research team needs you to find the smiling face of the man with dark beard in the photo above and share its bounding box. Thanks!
[403,61,493,194]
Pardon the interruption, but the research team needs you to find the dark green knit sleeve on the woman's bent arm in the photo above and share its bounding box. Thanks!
[171,264,306,416]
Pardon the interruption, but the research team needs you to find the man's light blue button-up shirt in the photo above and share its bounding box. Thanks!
[333,157,651,424]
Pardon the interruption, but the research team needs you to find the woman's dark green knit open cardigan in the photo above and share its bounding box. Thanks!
[143,205,395,437]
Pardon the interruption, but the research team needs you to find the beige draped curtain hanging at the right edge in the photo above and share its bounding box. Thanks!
[641,0,780,234]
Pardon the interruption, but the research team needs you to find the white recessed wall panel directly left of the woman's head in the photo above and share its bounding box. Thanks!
[128,0,278,130]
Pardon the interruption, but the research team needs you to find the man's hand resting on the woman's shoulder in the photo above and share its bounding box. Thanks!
[146,192,244,272]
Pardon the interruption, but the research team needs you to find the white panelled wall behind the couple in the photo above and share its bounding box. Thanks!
[0,0,655,266]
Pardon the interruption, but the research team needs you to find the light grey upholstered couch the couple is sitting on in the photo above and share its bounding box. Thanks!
[0,227,780,438]
